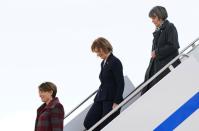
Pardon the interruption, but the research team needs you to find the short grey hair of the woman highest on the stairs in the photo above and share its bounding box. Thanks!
[149,6,168,21]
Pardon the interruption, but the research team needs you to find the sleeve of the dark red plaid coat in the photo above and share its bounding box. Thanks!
[50,105,64,131]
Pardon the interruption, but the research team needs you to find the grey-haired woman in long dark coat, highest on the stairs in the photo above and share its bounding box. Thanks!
[142,6,180,94]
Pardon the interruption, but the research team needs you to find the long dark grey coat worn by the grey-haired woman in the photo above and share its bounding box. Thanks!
[142,20,180,94]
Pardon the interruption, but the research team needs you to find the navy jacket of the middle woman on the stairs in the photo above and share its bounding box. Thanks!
[94,53,124,104]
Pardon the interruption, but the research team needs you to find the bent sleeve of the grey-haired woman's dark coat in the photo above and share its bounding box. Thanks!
[155,24,179,59]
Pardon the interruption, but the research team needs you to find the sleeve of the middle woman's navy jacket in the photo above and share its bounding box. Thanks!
[112,60,124,104]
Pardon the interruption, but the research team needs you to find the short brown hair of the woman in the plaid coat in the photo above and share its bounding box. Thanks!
[39,82,57,98]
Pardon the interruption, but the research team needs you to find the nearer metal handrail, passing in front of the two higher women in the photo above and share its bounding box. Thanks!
[88,37,199,131]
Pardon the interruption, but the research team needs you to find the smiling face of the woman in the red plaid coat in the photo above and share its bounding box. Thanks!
[39,90,53,103]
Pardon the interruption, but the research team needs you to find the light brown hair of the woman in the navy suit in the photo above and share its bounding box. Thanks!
[91,37,113,53]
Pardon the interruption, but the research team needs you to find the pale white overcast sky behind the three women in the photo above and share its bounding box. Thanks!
[0,0,199,131]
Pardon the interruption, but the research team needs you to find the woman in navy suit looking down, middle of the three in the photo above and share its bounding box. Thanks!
[84,37,124,131]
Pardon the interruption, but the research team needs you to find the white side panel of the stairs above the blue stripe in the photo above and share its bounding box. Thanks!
[103,56,199,131]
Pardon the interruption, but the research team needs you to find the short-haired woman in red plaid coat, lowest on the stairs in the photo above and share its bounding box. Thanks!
[35,82,64,131]
